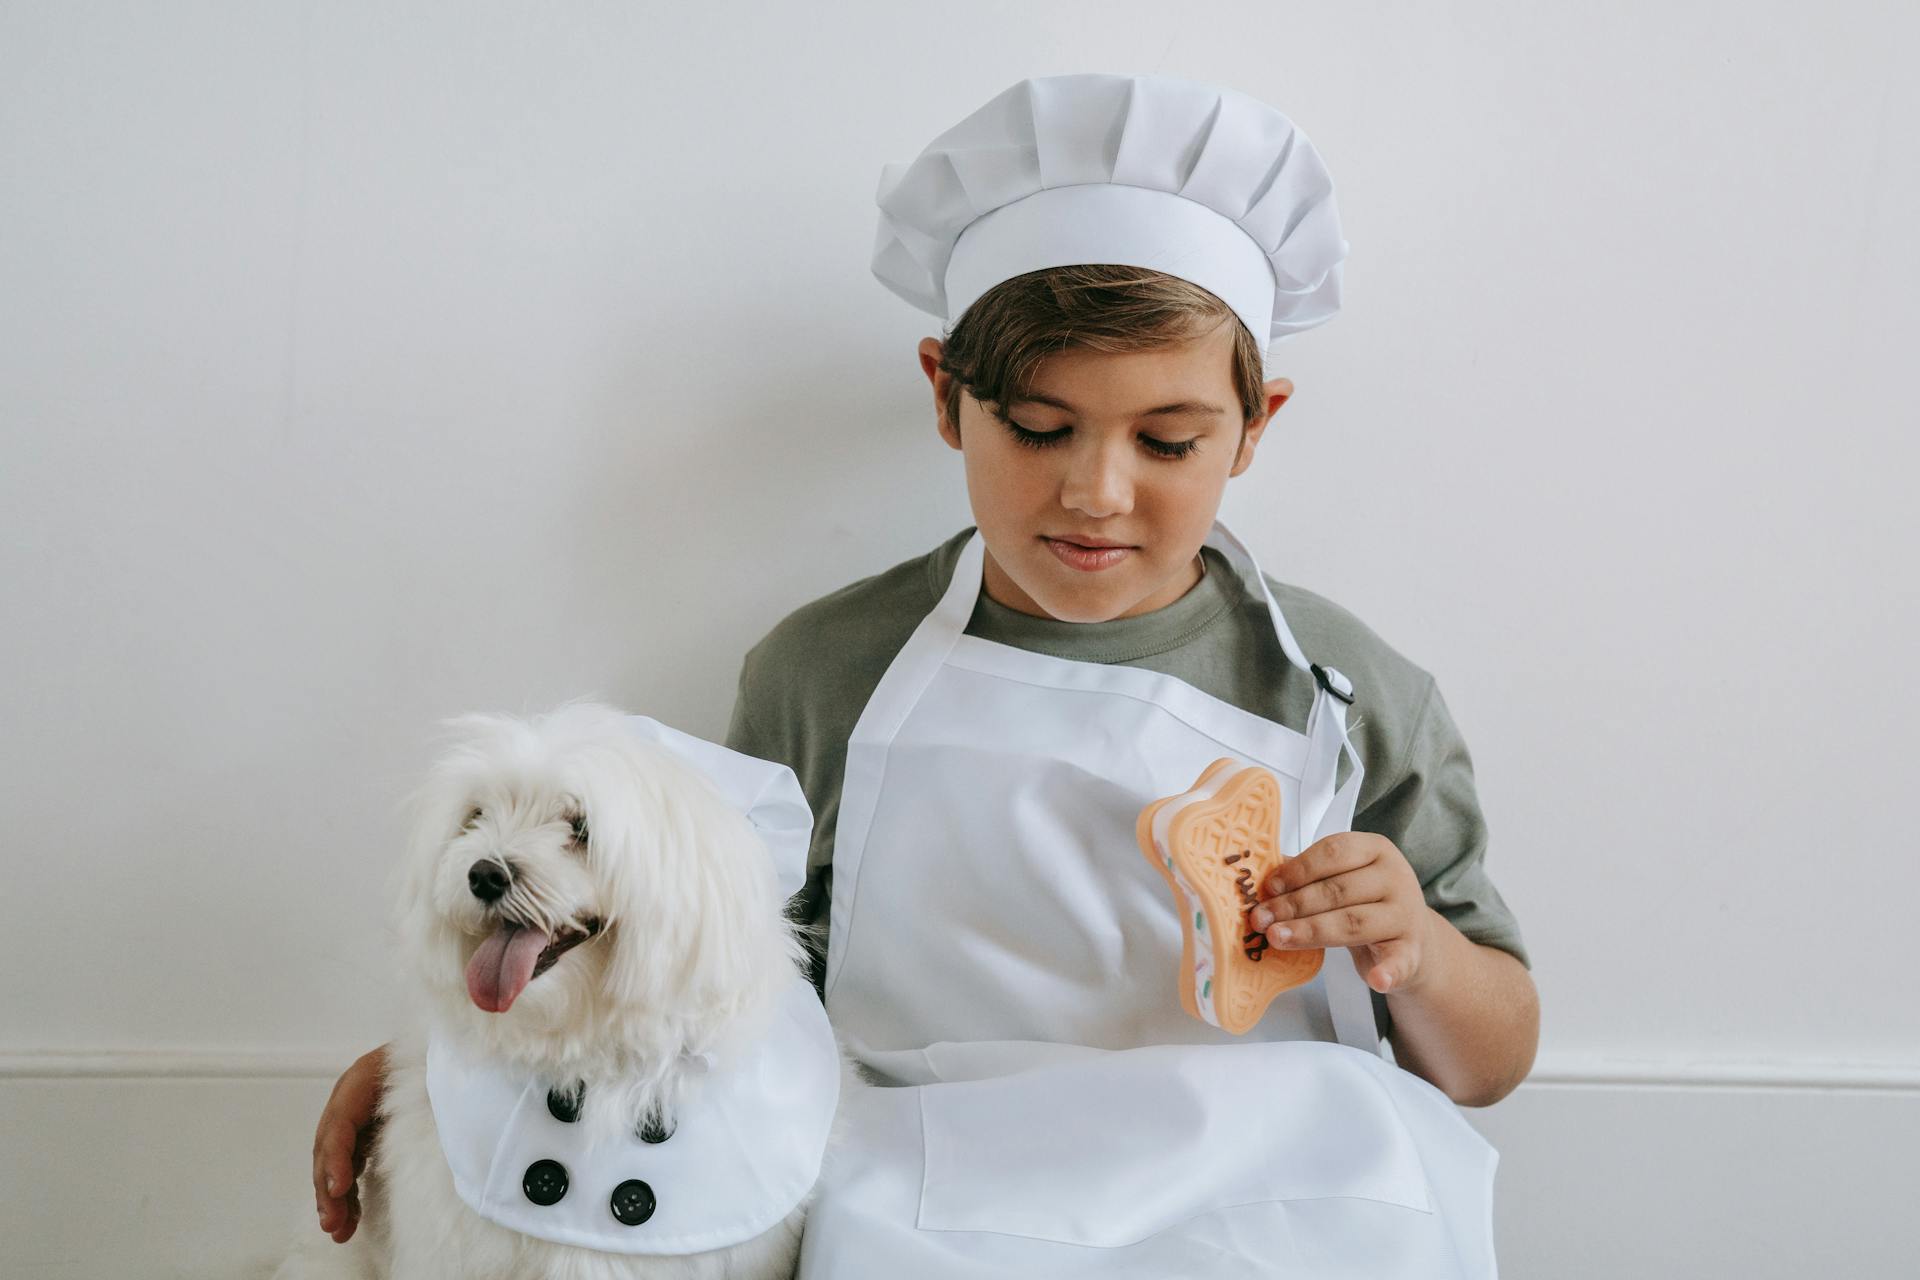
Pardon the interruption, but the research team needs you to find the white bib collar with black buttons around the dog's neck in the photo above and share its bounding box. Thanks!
[426,977,841,1253]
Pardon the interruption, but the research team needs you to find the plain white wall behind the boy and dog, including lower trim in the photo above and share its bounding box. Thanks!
[0,0,1920,1278]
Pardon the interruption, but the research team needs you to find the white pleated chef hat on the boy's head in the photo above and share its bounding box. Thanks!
[874,75,1348,368]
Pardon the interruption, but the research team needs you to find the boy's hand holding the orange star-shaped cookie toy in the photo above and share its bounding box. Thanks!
[1248,831,1444,994]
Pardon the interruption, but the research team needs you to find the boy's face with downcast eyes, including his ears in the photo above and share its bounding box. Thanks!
[920,324,1294,622]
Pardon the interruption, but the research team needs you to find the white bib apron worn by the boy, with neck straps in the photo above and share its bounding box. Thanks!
[801,524,1496,1280]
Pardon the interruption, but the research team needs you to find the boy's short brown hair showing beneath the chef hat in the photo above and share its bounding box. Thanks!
[939,265,1267,452]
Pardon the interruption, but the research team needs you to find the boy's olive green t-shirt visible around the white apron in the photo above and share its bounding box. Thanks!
[728,528,1530,986]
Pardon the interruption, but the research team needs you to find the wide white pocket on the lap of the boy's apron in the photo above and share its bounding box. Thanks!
[916,1040,1432,1247]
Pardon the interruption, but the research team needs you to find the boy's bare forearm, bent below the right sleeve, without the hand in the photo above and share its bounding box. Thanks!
[1386,908,1540,1107]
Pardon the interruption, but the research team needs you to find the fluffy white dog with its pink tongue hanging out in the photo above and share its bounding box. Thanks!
[278,702,860,1280]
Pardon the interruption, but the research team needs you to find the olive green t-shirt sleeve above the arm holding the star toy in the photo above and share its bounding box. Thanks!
[1354,677,1532,967]
